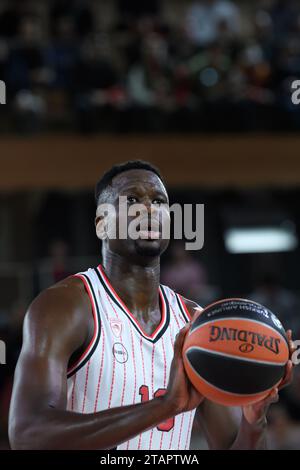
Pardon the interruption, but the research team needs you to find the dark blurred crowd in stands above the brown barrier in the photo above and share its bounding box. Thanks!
[0,0,300,133]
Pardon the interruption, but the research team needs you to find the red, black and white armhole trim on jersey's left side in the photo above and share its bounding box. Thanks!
[67,273,101,379]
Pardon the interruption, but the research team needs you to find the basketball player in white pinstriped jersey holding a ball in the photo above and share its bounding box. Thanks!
[9,161,292,450]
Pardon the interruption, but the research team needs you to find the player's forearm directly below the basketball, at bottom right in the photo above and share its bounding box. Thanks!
[231,416,267,450]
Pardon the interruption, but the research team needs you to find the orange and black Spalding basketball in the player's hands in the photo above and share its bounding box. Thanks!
[183,299,289,406]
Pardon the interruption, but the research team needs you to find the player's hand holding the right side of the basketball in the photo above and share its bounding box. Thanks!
[242,330,296,425]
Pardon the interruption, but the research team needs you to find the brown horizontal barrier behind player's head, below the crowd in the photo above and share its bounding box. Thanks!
[0,135,300,191]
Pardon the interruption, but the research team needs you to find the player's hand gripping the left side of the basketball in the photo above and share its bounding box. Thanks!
[164,323,204,414]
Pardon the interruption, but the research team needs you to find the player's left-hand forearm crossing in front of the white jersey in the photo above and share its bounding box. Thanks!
[10,397,174,450]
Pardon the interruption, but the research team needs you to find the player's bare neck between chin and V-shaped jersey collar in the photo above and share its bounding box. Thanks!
[102,250,160,316]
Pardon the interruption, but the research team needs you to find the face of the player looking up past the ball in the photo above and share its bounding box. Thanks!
[96,170,170,261]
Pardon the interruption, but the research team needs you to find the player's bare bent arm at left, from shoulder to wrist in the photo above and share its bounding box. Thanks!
[9,278,178,449]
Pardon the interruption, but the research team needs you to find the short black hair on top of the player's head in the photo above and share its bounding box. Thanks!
[95,160,164,205]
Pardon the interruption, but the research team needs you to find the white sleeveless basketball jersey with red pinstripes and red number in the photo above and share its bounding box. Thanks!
[68,266,194,450]
